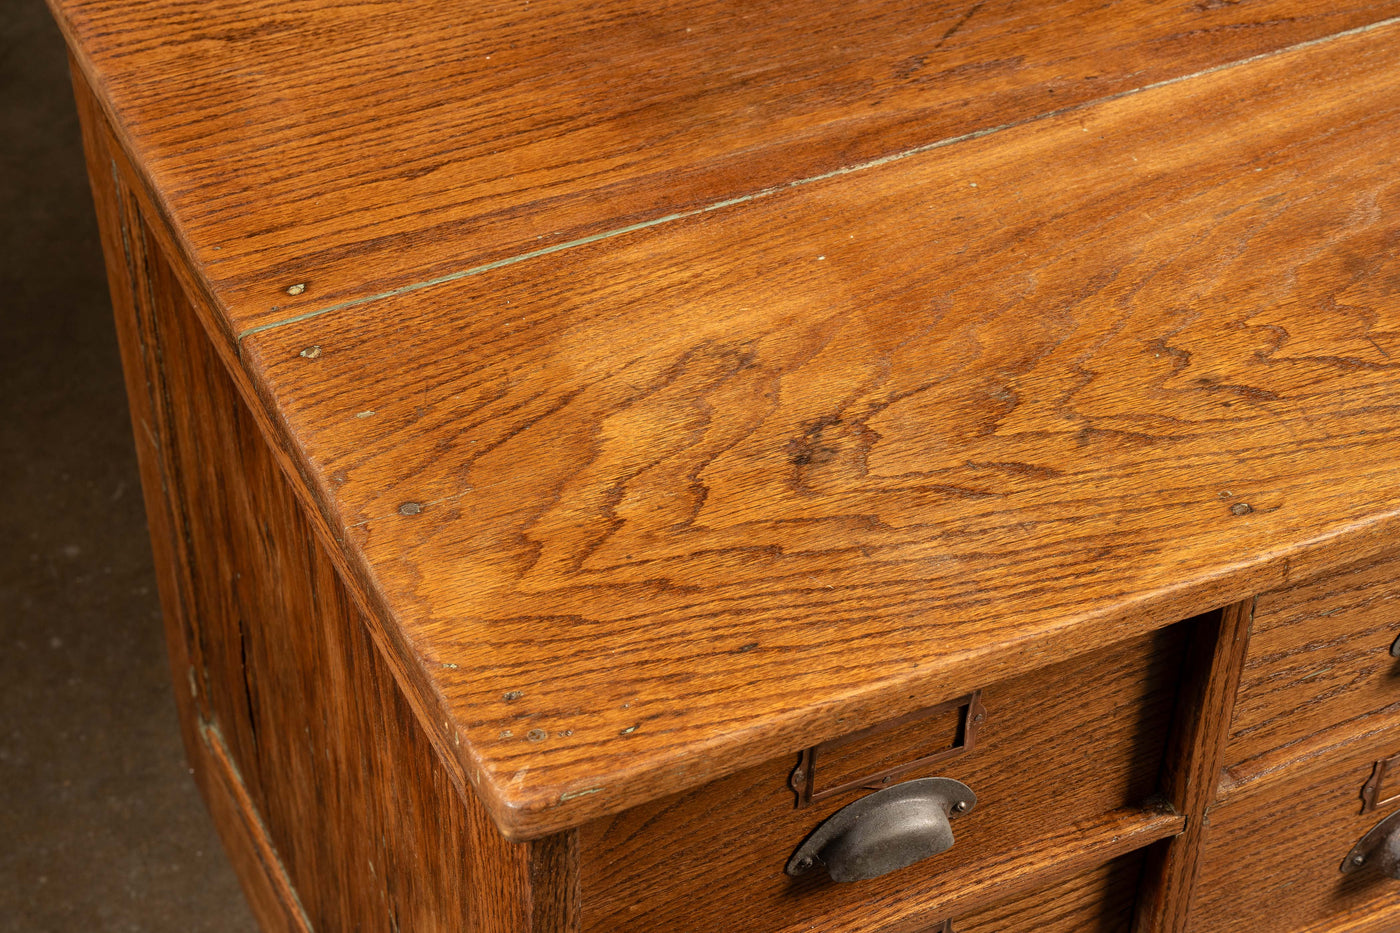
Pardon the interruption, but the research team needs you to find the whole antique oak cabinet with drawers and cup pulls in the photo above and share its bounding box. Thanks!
[52,0,1400,933]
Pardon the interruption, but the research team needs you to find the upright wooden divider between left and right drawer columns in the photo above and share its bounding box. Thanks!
[1133,598,1256,933]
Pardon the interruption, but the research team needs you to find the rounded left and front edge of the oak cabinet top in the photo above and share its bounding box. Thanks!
[60,7,1400,842]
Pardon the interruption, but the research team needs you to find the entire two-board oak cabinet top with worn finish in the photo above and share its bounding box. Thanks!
[53,0,1400,838]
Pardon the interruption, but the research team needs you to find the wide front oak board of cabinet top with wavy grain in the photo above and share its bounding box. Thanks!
[226,27,1400,838]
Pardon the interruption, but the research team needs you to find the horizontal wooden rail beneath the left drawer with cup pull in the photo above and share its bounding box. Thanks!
[781,808,1186,933]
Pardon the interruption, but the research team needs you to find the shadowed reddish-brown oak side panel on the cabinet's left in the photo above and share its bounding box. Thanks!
[65,65,574,933]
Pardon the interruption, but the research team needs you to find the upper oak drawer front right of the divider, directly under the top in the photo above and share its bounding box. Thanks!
[1226,556,1400,782]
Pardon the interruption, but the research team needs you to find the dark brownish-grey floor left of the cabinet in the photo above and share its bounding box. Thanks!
[0,0,255,933]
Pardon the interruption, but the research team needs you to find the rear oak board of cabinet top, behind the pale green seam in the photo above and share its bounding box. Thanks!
[50,0,1400,338]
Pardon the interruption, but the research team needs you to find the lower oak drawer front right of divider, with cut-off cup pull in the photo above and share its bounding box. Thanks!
[1189,730,1400,933]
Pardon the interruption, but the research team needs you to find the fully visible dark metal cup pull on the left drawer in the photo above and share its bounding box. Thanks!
[787,778,977,881]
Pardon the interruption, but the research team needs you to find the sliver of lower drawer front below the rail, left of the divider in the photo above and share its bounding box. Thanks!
[952,852,1142,933]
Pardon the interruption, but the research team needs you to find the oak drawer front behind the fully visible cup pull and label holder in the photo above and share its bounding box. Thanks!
[580,625,1187,933]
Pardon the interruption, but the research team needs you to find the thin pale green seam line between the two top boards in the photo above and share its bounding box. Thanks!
[235,10,1400,354]
